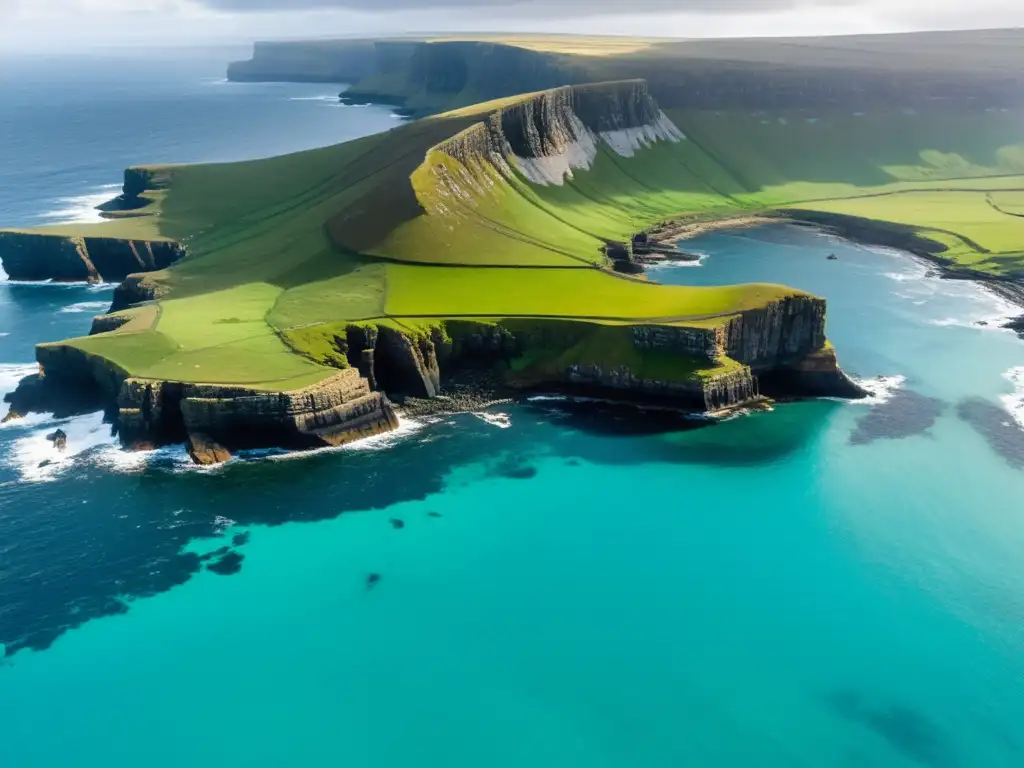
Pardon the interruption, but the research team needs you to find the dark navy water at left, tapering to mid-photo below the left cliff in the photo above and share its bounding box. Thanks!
[0,418,507,656]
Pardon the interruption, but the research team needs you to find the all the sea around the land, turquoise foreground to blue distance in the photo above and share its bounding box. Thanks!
[0,57,1024,768]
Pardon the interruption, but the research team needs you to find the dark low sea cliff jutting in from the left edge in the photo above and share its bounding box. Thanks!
[0,231,184,283]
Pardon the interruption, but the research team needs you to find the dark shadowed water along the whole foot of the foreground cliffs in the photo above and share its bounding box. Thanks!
[0,402,838,656]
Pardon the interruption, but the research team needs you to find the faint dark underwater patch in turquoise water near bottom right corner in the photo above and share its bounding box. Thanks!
[825,691,959,768]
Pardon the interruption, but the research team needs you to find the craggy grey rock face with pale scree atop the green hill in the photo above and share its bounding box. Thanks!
[435,80,684,188]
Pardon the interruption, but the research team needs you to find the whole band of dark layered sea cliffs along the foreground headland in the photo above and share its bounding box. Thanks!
[10,295,863,462]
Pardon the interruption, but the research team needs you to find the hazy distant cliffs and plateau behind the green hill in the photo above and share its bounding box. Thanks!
[228,30,1024,115]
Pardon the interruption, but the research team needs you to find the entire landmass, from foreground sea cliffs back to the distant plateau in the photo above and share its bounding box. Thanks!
[0,30,1024,463]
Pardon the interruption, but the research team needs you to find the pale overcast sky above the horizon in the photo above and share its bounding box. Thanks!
[0,0,1024,52]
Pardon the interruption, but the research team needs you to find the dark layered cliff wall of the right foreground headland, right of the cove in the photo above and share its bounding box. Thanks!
[321,295,864,411]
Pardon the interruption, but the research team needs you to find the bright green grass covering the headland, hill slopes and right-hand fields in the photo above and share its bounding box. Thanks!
[9,63,1024,390]
